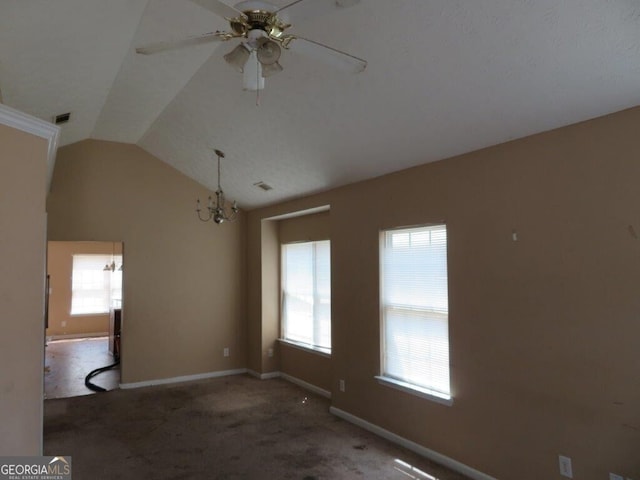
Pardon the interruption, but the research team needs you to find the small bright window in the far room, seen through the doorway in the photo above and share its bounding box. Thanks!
[71,255,122,315]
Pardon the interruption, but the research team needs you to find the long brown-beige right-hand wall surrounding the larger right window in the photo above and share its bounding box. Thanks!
[248,108,640,480]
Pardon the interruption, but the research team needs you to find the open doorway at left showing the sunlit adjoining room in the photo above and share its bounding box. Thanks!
[44,241,124,398]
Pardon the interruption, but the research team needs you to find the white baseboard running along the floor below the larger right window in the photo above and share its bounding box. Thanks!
[329,407,496,480]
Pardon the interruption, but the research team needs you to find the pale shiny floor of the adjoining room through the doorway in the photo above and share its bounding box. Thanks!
[44,337,120,398]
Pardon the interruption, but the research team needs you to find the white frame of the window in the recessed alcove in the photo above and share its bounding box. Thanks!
[278,239,332,357]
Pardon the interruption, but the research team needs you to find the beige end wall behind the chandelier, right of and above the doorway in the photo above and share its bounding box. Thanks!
[48,140,246,384]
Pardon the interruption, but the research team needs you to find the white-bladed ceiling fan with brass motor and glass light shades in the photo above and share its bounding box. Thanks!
[136,0,367,91]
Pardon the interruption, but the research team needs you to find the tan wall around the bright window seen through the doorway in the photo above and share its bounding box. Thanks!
[47,242,122,337]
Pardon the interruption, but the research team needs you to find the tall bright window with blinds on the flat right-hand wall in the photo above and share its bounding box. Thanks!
[378,225,451,403]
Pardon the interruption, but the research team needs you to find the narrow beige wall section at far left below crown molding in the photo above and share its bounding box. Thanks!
[0,125,48,455]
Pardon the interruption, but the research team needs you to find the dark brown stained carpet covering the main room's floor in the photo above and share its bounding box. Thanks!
[44,375,466,480]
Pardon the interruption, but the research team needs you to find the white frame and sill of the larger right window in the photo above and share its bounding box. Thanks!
[375,222,453,406]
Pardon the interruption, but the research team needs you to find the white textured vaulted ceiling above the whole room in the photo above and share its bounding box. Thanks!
[0,0,640,208]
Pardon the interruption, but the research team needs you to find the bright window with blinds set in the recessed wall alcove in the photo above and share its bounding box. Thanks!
[282,240,331,351]
